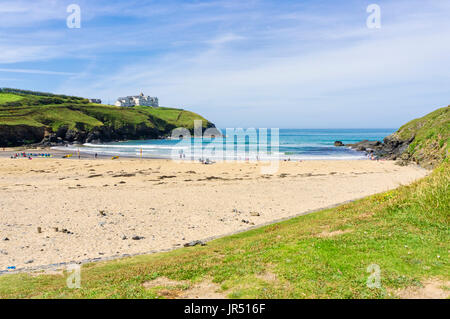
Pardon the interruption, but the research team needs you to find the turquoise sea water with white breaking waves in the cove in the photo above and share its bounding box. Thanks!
[55,129,395,160]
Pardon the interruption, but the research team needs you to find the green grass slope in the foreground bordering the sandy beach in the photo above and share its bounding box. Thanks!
[0,163,450,298]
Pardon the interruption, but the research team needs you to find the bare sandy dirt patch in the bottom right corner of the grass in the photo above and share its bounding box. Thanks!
[396,279,450,299]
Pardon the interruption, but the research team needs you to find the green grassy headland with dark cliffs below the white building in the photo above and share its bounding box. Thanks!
[0,89,214,146]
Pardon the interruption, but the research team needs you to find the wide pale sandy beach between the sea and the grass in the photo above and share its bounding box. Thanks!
[0,151,428,271]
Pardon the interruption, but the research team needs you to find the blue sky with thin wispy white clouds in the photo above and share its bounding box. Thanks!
[0,0,450,128]
